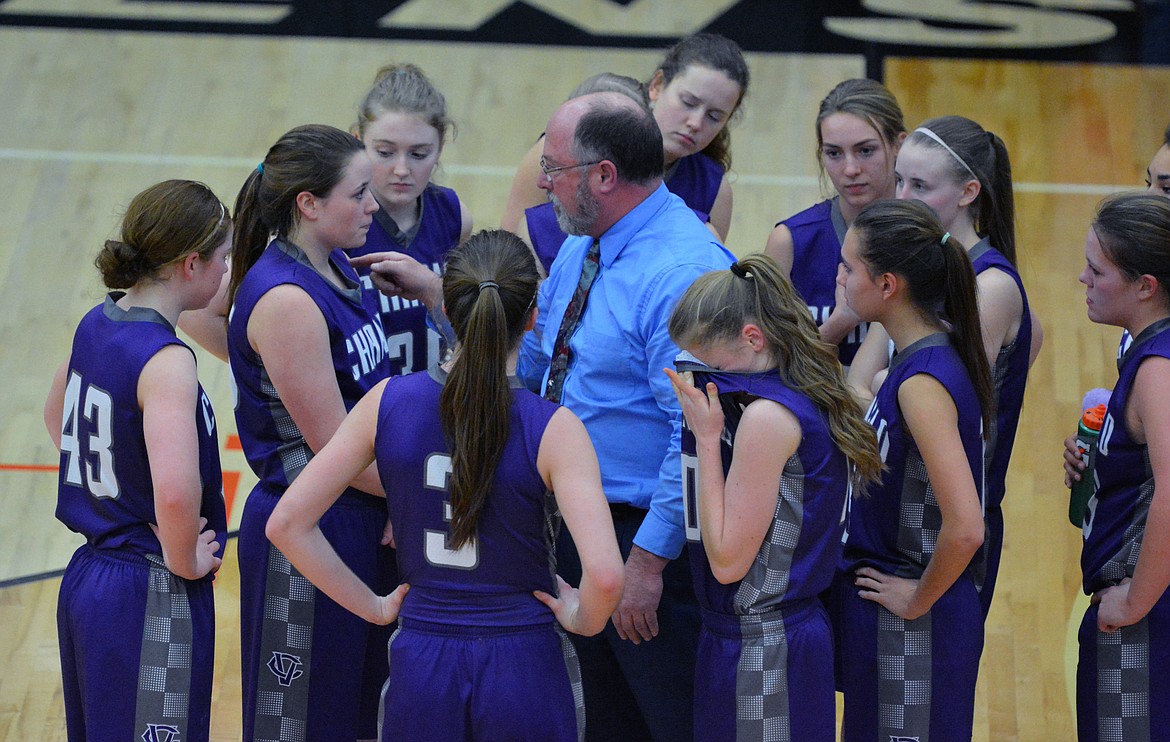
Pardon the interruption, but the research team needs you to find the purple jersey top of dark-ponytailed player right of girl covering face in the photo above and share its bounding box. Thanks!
[842,332,983,585]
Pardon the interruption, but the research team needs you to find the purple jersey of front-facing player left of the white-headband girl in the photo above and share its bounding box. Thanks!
[777,198,868,365]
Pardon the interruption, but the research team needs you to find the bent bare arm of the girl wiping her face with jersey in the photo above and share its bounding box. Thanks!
[666,369,800,584]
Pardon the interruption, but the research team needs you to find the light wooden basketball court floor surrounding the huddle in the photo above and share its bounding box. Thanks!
[0,20,1170,741]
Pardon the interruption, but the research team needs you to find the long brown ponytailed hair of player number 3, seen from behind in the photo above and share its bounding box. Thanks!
[439,231,539,549]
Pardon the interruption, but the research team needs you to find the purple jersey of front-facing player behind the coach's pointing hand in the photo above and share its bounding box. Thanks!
[350,185,463,375]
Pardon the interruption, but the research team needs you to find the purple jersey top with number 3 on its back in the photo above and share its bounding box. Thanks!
[374,370,560,626]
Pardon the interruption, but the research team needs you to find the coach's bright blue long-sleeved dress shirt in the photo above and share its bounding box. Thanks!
[517,185,735,559]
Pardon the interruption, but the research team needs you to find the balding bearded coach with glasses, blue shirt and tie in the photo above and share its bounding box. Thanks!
[517,92,734,741]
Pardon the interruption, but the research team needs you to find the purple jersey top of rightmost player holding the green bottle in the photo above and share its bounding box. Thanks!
[1081,320,1170,595]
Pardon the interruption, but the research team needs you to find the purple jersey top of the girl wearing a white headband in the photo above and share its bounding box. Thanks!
[970,239,1032,508]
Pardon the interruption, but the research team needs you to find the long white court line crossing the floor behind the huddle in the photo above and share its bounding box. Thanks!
[0,147,1137,195]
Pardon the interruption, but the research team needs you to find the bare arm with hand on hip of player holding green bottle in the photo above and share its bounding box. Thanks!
[1096,356,1170,632]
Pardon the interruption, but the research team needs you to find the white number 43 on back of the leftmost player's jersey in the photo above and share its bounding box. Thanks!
[61,371,119,497]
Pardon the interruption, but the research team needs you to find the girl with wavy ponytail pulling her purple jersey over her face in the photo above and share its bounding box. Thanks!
[667,255,881,741]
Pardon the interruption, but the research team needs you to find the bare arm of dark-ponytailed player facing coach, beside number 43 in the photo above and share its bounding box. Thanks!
[248,284,385,495]
